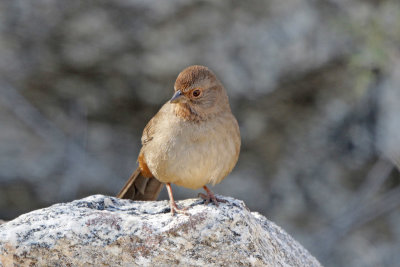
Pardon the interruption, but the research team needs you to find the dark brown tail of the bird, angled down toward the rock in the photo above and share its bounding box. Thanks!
[117,167,164,200]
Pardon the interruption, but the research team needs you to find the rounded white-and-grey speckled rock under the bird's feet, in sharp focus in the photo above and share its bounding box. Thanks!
[0,195,321,266]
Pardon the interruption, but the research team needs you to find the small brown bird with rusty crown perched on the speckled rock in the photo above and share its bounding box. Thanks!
[117,65,240,214]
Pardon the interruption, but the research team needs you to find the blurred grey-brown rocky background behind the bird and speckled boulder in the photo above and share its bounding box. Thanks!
[0,0,400,266]
